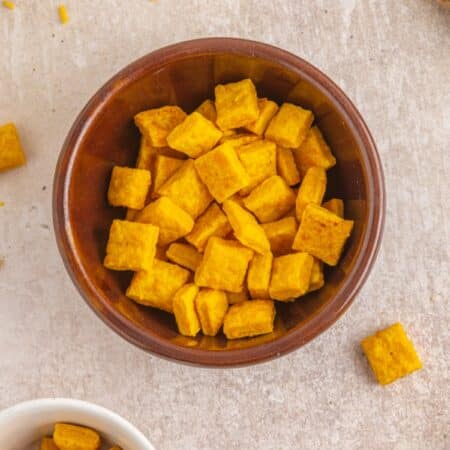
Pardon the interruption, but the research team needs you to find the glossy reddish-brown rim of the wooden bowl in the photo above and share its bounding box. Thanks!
[53,38,385,367]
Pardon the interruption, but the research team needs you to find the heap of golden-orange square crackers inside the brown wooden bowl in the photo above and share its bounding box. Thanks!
[104,79,353,339]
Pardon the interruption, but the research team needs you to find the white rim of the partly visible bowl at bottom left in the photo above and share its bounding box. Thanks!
[0,397,155,450]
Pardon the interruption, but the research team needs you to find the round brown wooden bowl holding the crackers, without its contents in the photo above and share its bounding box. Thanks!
[53,38,385,366]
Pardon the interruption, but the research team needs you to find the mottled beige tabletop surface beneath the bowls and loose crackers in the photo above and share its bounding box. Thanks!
[0,0,450,450]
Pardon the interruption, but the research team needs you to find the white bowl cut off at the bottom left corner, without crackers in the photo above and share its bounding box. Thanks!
[0,398,154,450]
